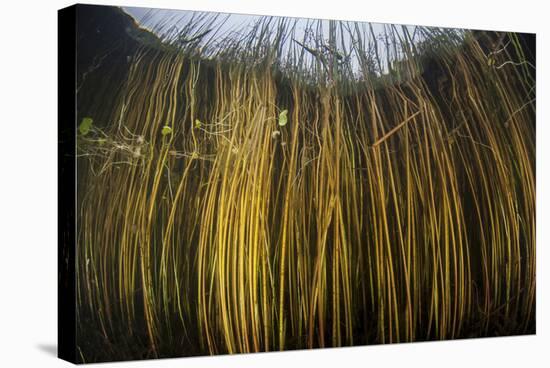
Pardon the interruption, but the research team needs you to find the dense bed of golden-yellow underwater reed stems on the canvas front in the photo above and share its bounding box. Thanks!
[77,12,535,361]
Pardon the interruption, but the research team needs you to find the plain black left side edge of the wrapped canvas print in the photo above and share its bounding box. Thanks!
[57,5,77,363]
